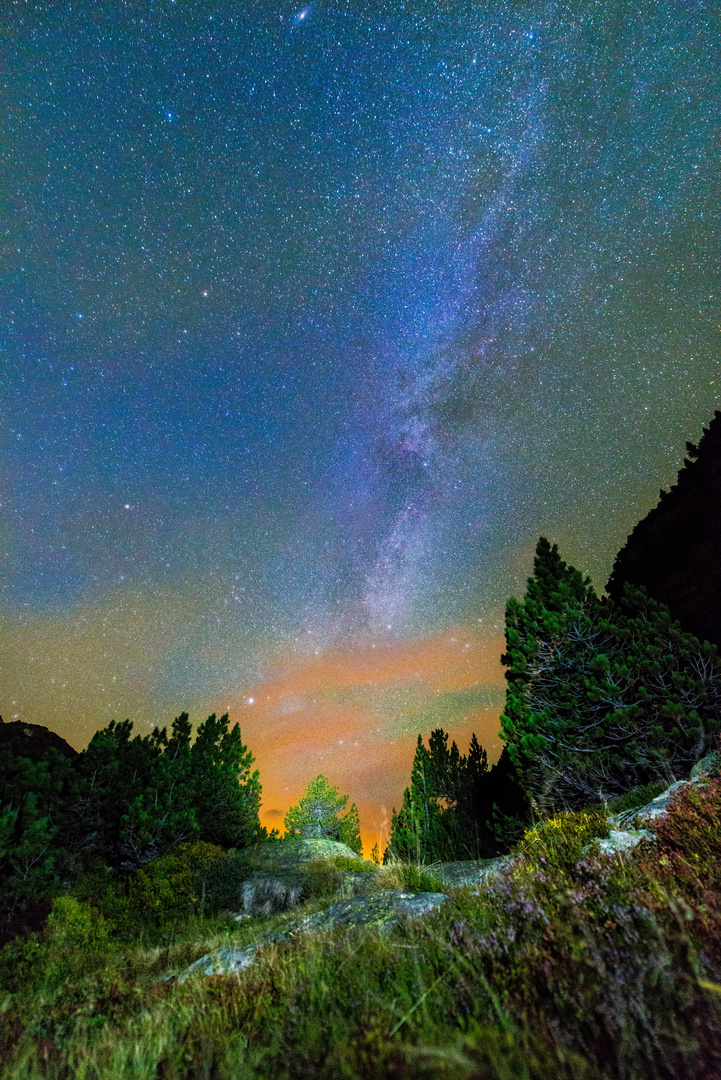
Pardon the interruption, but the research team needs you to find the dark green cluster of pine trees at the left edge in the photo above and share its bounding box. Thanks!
[0,713,264,932]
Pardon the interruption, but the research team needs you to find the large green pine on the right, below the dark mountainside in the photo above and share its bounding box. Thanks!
[501,538,721,813]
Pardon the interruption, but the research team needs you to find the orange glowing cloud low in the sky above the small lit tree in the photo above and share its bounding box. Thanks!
[216,627,504,853]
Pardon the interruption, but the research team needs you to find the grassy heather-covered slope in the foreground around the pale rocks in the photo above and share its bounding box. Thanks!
[0,780,721,1080]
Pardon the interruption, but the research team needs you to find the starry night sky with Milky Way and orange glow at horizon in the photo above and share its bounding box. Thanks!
[0,0,721,845]
